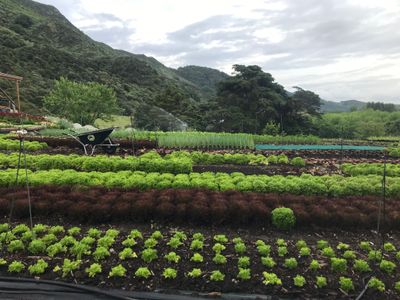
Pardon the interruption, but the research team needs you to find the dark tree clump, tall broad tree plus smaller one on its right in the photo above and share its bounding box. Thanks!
[212,65,321,133]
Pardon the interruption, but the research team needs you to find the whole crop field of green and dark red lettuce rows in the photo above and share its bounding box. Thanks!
[0,132,400,299]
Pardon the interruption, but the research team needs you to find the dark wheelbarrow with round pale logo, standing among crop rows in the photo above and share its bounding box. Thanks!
[67,128,119,155]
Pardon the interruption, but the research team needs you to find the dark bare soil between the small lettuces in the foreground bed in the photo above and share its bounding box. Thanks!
[0,218,400,299]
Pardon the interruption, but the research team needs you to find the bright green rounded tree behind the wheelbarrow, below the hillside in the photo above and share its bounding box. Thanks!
[44,77,118,125]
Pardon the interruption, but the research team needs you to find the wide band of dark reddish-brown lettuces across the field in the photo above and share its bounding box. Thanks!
[0,186,400,229]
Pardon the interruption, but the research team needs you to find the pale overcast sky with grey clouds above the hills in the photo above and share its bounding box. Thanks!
[38,0,400,103]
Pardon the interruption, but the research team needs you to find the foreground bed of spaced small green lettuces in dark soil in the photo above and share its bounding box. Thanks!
[0,219,400,299]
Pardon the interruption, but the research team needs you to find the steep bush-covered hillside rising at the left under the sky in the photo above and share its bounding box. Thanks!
[0,0,218,119]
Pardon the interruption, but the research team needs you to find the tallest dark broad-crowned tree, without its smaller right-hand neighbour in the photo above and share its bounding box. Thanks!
[215,65,288,133]
